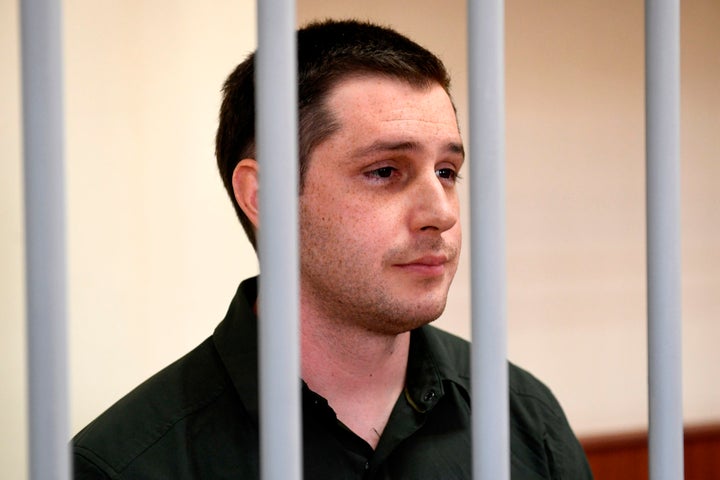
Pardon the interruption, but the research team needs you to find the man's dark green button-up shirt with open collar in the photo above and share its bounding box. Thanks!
[73,279,592,480]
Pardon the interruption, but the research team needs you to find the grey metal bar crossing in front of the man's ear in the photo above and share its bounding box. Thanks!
[255,0,302,480]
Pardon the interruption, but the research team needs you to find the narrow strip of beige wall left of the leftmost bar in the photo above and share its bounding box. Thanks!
[0,0,27,479]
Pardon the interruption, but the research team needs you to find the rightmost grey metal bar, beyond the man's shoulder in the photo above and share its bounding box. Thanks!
[645,0,683,480]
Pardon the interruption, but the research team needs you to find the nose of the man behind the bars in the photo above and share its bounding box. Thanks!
[409,170,459,233]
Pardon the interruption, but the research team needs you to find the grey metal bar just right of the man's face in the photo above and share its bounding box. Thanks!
[468,0,510,480]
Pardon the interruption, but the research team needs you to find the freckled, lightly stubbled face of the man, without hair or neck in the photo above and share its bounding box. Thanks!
[300,76,464,334]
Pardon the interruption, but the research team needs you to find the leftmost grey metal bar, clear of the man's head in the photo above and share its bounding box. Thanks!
[20,0,70,479]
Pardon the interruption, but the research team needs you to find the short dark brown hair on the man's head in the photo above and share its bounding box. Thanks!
[215,20,450,247]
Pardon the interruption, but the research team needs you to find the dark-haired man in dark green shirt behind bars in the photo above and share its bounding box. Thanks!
[74,22,591,480]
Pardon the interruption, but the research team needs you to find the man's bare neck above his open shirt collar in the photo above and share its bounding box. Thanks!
[301,306,410,448]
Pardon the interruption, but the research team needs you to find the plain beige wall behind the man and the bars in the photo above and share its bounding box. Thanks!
[0,0,720,478]
